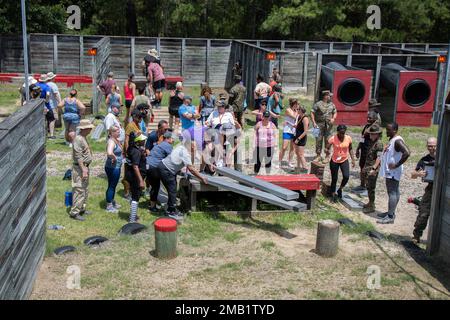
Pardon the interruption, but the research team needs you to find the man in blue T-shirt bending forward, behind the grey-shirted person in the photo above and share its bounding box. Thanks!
[147,132,174,212]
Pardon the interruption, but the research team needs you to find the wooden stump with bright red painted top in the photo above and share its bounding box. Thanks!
[155,218,177,259]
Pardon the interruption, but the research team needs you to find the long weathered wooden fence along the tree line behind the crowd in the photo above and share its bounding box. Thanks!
[0,34,447,88]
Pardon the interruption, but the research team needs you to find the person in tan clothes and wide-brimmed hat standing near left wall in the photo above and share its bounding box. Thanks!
[69,119,95,221]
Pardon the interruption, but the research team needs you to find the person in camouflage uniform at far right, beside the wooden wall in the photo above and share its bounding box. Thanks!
[411,138,437,243]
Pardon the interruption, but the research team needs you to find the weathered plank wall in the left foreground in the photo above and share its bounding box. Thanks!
[0,101,46,300]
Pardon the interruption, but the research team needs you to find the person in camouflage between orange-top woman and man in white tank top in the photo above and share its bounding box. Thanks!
[362,123,384,213]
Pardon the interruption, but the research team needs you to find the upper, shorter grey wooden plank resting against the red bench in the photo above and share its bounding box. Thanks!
[216,167,299,201]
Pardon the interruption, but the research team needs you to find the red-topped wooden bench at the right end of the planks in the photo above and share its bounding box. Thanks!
[256,174,320,210]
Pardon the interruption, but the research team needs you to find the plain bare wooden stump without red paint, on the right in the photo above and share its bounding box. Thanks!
[316,220,339,258]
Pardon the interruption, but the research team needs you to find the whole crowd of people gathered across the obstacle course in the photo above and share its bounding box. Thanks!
[20,49,437,241]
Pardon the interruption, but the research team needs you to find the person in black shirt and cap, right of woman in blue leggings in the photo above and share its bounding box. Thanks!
[125,133,147,223]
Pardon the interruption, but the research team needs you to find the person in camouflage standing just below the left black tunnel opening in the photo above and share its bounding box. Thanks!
[311,90,337,161]
